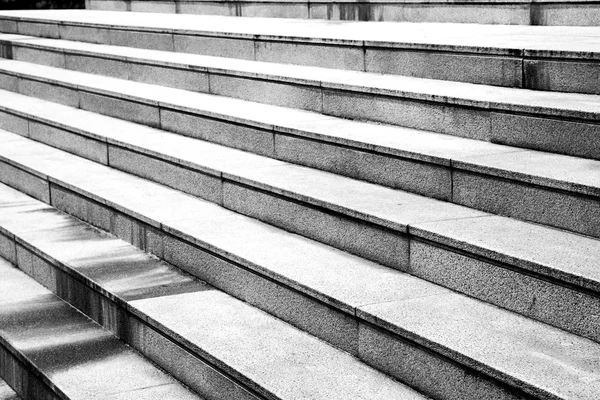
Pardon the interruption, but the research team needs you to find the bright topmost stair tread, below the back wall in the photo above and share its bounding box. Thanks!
[0,10,600,58]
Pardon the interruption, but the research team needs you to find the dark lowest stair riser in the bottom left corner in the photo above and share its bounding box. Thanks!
[0,341,60,400]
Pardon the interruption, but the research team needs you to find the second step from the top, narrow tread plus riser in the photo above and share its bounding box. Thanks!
[0,35,600,159]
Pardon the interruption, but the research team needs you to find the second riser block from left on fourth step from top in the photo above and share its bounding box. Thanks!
[29,122,108,165]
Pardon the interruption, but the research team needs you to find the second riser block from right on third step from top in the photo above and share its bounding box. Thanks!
[275,134,451,200]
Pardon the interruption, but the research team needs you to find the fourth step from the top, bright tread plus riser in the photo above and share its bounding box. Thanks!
[0,92,600,346]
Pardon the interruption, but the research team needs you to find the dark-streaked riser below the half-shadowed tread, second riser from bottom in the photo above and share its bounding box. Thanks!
[0,232,262,400]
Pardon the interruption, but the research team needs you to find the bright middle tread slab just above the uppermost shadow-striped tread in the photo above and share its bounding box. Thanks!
[163,213,442,314]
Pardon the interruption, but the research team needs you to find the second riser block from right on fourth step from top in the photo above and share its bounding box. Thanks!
[223,182,408,270]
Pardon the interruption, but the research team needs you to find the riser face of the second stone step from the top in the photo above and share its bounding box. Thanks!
[3,42,600,162]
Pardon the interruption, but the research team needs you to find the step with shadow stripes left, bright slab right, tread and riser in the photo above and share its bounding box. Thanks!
[0,185,426,400]
